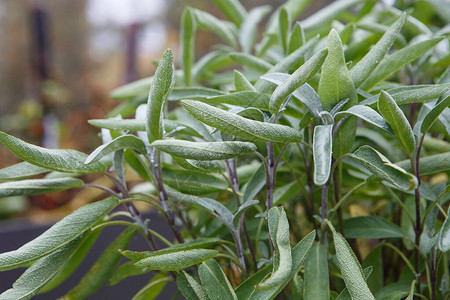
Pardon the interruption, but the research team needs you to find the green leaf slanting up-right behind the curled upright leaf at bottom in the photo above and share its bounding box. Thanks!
[246,231,316,300]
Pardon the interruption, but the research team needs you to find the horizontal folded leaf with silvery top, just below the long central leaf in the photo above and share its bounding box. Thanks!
[151,139,256,160]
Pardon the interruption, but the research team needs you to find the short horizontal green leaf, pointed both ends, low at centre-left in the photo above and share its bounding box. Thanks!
[131,249,219,271]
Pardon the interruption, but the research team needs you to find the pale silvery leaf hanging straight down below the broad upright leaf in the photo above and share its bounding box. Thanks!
[313,125,333,185]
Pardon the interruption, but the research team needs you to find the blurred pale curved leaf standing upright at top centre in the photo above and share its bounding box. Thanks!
[239,5,271,53]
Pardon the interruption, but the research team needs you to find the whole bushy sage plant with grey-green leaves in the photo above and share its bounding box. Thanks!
[0,0,450,299]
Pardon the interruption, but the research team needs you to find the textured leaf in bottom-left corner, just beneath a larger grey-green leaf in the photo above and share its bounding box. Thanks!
[0,236,83,300]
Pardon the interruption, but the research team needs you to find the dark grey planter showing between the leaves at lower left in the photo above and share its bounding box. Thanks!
[0,212,178,300]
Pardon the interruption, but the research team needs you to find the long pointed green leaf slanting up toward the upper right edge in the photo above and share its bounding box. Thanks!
[360,37,443,91]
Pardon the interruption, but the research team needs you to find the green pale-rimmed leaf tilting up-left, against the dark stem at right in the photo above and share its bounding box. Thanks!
[378,91,416,157]
